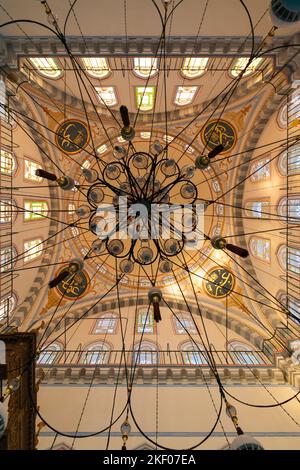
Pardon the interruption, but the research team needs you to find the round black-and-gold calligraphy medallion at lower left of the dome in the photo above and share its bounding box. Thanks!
[56,268,90,300]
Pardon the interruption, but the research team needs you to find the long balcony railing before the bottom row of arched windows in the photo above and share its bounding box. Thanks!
[37,350,272,367]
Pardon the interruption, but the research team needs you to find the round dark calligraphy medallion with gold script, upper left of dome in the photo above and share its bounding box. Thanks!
[55,119,90,155]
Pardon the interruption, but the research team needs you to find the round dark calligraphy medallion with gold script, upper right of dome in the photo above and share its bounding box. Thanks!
[201,119,237,152]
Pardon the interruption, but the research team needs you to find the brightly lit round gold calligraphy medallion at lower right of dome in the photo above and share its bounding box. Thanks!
[203,268,234,299]
